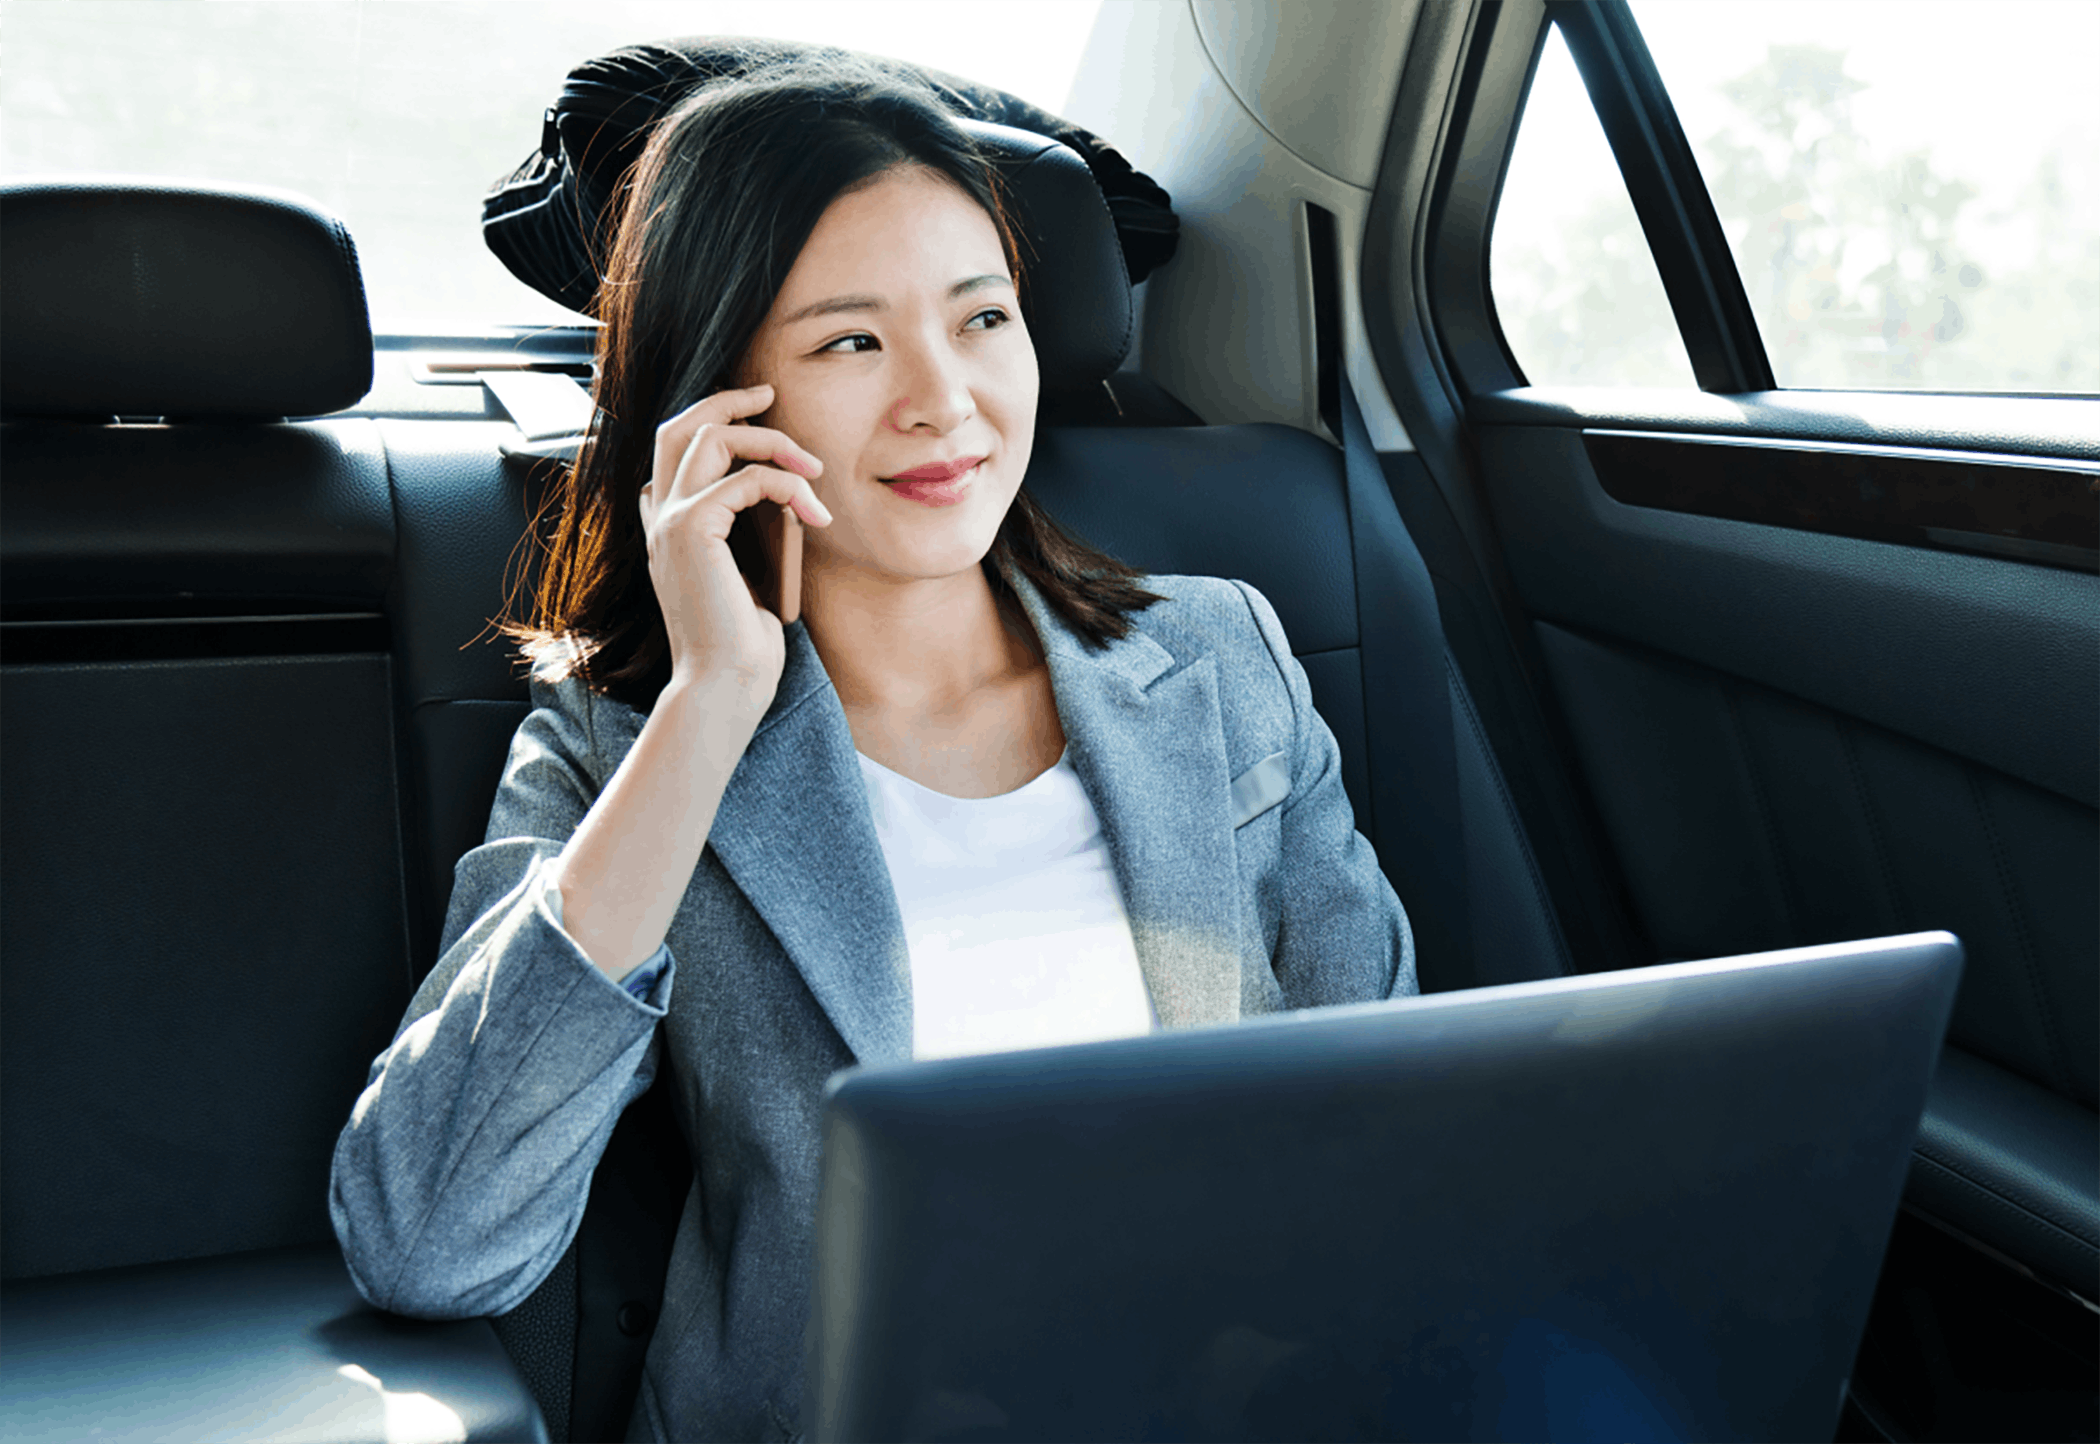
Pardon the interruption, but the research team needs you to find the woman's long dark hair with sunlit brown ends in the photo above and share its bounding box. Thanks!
[504,61,1161,707]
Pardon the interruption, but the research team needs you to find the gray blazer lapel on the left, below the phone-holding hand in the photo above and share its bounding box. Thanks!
[708,623,911,1062]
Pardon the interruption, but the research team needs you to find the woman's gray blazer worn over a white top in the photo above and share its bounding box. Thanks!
[330,575,1415,1440]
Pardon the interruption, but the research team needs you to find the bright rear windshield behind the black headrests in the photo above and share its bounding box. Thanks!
[0,0,1100,332]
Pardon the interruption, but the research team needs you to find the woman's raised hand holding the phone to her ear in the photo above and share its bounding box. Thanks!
[641,386,832,709]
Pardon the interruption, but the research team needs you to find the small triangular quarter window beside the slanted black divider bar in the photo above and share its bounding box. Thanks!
[1489,29,1697,386]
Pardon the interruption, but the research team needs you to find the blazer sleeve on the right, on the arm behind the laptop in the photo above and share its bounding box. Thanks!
[1233,581,1420,1007]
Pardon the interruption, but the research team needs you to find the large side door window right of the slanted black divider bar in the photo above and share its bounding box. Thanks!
[1637,0,2100,392]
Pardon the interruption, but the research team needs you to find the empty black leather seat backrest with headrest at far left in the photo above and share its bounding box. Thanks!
[0,185,412,1278]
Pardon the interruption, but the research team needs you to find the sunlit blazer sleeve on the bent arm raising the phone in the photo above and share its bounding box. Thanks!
[328,684,676,1318]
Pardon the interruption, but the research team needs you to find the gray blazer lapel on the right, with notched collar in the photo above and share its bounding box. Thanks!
[1006,571,1241,1028]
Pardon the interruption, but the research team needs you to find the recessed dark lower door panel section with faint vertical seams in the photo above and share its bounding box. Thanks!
[1539,625,2100,1108]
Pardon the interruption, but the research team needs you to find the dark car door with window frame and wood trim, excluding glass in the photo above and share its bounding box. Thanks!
[1363,19,2100,1440]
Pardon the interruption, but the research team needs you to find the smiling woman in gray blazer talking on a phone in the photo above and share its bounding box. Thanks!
[332,59,1413,1438]
